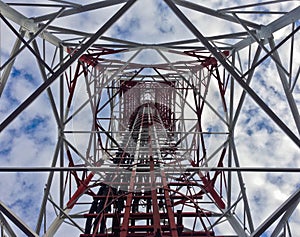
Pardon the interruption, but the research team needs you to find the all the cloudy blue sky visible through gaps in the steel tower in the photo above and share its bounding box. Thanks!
[0,0,300,236]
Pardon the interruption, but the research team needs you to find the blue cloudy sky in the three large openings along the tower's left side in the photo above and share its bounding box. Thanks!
[0,67,56,235]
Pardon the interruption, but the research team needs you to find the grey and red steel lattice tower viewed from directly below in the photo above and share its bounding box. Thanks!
[0,0,300,237]
